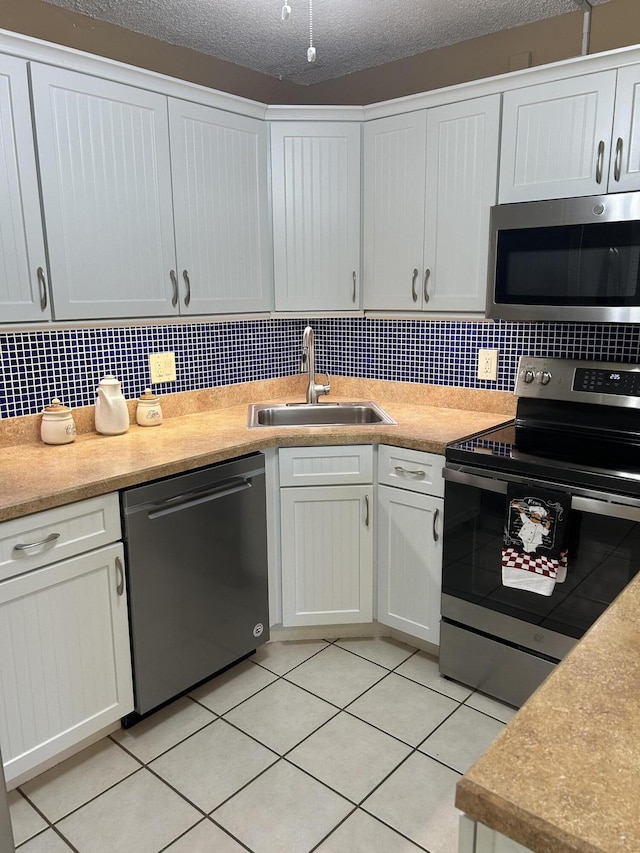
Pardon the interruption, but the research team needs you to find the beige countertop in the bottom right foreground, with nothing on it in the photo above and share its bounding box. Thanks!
[456,564,640,853]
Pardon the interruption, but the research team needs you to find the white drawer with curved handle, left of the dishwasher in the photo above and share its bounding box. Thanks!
[0,492,121,580]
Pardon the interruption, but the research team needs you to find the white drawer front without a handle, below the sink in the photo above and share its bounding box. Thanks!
[279,444,373,486]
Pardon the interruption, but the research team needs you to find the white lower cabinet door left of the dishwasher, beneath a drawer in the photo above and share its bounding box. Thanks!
[0,544,133,781]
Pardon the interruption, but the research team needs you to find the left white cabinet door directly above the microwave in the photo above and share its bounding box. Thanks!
[499,71,616,204]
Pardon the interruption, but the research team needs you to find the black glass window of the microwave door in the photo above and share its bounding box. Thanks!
[495,220,640,307]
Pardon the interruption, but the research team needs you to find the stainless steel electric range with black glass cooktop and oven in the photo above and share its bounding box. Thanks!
[440,357,640,706]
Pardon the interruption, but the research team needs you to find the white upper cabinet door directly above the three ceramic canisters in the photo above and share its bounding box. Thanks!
[32,65,177,320]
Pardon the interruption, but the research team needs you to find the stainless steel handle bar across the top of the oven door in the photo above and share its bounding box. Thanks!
[442,468,640,521]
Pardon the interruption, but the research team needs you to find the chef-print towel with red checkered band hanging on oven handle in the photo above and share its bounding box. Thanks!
[502,483,571,595]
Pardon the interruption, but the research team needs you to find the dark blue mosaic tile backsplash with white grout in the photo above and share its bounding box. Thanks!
[0,317,640,418]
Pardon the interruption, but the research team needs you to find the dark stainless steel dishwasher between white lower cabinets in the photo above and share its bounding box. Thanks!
[122,453,269,727]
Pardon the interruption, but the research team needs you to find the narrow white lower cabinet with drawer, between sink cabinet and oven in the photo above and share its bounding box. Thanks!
[377,445,444,645]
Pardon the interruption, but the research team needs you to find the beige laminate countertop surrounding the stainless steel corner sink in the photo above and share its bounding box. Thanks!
[0,377,514,521]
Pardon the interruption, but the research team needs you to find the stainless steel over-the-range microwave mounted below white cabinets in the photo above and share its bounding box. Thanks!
[487,192,640,323]
